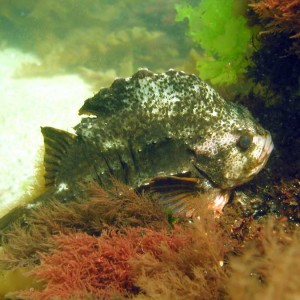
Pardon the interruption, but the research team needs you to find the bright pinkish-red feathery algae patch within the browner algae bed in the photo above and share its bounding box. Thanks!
[19,228,189,300]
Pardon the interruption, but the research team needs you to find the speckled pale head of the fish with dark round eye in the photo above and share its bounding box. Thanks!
[192,105,274,189]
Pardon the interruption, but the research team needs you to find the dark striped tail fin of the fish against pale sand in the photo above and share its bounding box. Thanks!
[41,127,76,186]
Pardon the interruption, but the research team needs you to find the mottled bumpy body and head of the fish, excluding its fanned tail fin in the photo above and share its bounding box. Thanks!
[62,69,273,189]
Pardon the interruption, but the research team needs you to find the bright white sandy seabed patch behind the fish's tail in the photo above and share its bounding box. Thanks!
[0,49,92,217]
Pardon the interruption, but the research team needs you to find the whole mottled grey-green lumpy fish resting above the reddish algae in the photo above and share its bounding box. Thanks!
[0,68,274,227]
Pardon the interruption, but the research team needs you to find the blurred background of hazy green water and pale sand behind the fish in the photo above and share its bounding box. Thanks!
[0,0,193,214]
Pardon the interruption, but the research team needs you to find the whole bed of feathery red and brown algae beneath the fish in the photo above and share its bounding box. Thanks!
[0,181,300,300]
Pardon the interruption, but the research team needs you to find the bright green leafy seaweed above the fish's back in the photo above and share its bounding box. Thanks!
[175,0,252,85]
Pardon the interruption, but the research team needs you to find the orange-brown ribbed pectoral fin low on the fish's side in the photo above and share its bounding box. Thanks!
[140,176,201,213]
